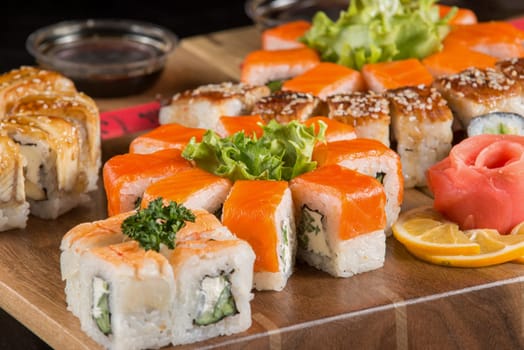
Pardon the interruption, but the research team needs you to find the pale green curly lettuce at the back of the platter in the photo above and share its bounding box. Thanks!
[301,0,456,70]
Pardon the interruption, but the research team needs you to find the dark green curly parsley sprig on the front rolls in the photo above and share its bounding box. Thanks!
[122,198,195,252]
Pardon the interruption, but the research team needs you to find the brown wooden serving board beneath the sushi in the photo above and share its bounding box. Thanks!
[0,28,524,349]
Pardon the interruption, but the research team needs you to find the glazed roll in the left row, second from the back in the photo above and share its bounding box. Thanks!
[8,91,101,191]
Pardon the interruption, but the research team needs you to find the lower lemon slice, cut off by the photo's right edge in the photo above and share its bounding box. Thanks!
[407,229,524,267]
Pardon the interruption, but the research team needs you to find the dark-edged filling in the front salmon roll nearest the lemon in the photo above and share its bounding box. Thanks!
[298,205,331,256]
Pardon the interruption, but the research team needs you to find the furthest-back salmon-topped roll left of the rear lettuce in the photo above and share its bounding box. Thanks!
[262,20,311,50]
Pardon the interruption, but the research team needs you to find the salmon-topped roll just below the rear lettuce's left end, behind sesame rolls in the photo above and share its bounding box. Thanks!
[282,62,365,99]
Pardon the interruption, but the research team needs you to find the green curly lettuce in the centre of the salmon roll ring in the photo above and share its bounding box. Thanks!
[182,121,326,181]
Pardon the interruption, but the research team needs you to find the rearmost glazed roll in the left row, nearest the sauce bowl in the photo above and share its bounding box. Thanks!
[0,66,76,117]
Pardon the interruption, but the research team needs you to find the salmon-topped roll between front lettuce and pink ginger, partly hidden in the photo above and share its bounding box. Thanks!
[313,138,404,235]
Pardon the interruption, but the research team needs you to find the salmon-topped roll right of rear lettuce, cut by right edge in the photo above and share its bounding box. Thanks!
[442,21,524,59]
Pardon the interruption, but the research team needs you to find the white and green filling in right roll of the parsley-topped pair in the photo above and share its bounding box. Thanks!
[193,274,238,326]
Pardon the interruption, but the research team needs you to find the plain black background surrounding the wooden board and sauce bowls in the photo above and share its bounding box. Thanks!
[0,0,524,350]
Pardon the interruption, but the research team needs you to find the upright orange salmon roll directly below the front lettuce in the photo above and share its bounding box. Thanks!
[222,180,296,291]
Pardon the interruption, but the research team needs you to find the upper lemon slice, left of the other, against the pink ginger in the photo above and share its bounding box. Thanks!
[393,207,481,255]
